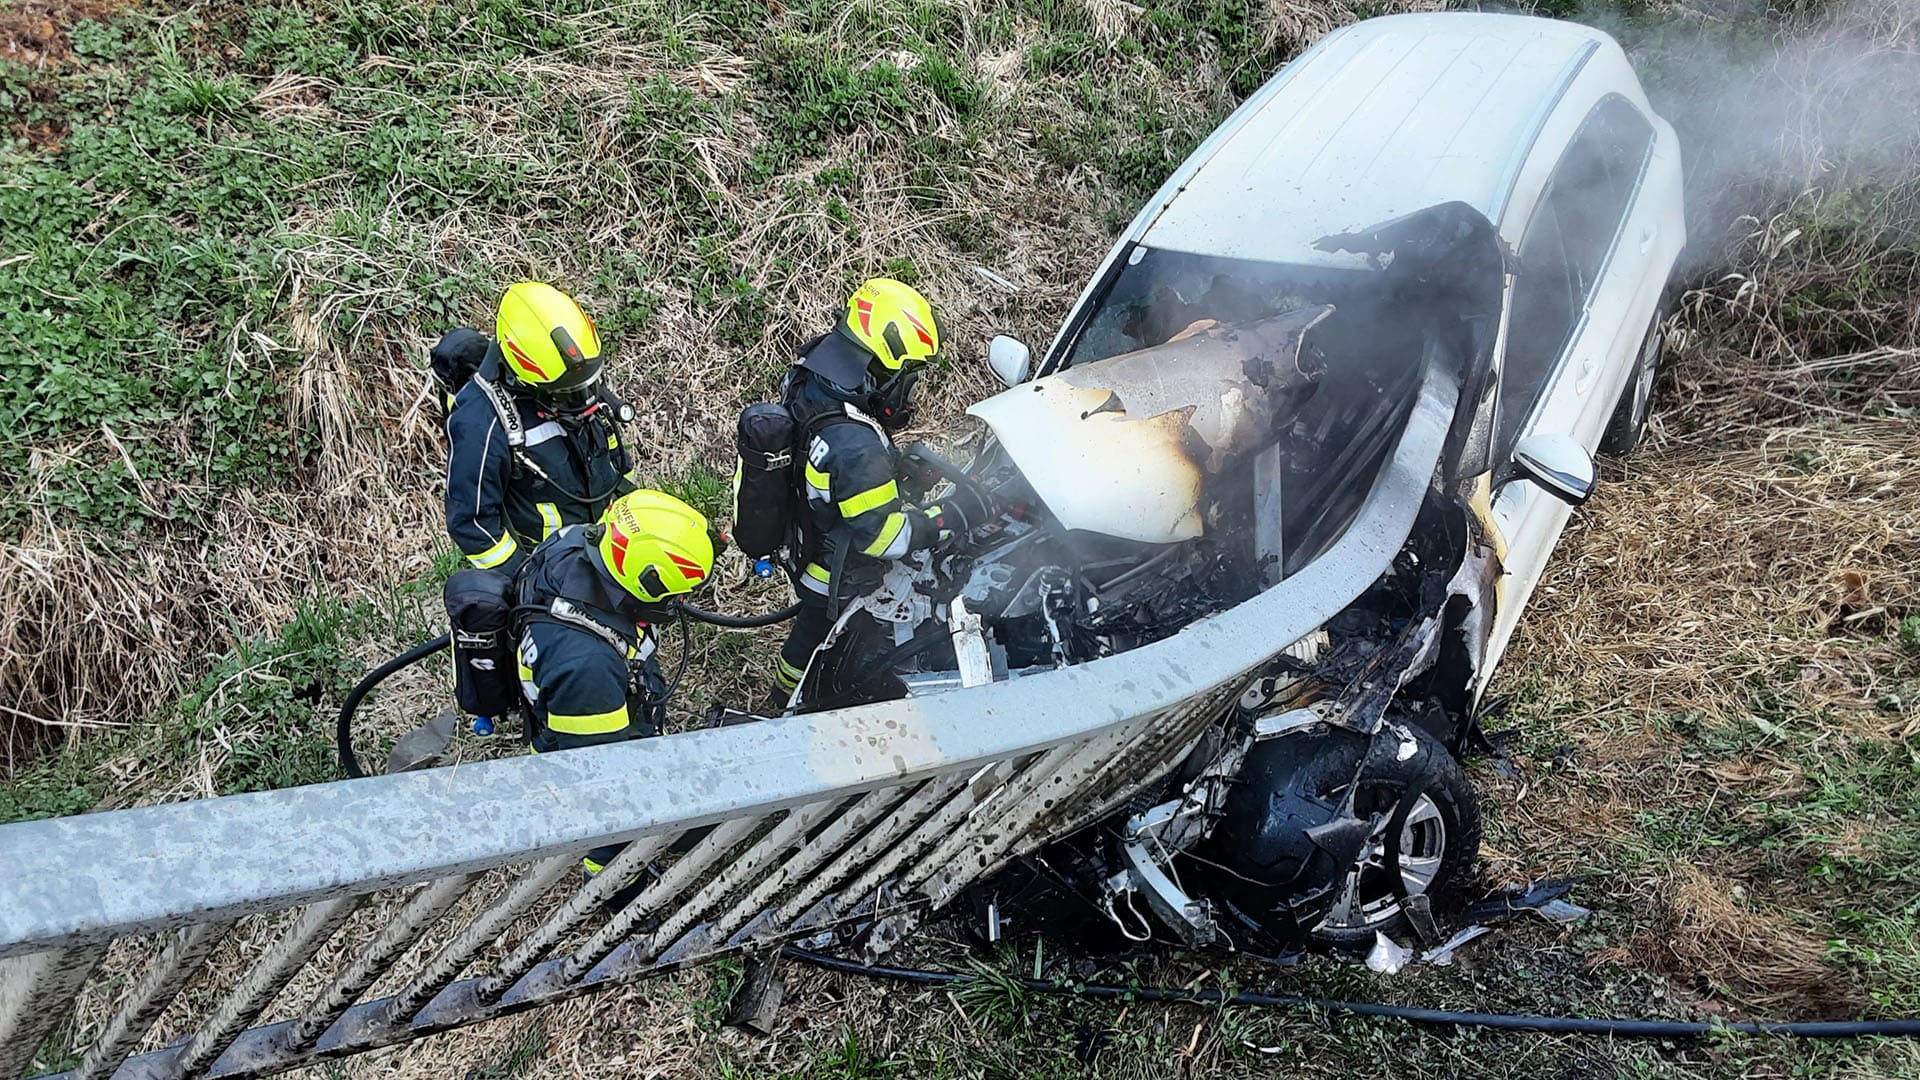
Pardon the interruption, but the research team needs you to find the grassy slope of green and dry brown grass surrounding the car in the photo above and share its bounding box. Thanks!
[0,0,1920,1076]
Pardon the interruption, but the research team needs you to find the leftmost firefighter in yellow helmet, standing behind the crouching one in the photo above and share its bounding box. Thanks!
[432,281,634,575]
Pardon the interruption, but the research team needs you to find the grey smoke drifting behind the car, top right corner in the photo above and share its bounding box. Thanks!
[1582,0,1920,275]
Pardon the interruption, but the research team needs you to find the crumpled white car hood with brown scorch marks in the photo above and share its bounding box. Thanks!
[968,306,1332,544]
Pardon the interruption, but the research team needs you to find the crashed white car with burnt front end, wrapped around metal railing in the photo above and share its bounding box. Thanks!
[804,13,1686,947]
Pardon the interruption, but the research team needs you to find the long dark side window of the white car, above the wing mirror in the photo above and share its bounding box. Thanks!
[1494,96,1653,459]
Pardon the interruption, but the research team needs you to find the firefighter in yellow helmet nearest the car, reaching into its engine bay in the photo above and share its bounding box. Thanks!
[756,277,981,703]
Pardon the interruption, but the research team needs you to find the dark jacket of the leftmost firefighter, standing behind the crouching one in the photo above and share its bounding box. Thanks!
[447,344,632,573]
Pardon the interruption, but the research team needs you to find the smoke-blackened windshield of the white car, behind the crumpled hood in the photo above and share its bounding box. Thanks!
[1064,248,1427,577]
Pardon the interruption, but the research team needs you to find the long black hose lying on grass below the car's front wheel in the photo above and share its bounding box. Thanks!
[781,945,1920,1040]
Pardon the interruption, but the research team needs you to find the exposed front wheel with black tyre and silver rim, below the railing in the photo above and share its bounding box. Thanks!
[1208,724,1480,949]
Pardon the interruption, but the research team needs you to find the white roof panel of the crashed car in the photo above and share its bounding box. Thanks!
[1140,12,1638,265]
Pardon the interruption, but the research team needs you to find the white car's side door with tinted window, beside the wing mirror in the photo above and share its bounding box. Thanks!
[1480,96,1657,673]
